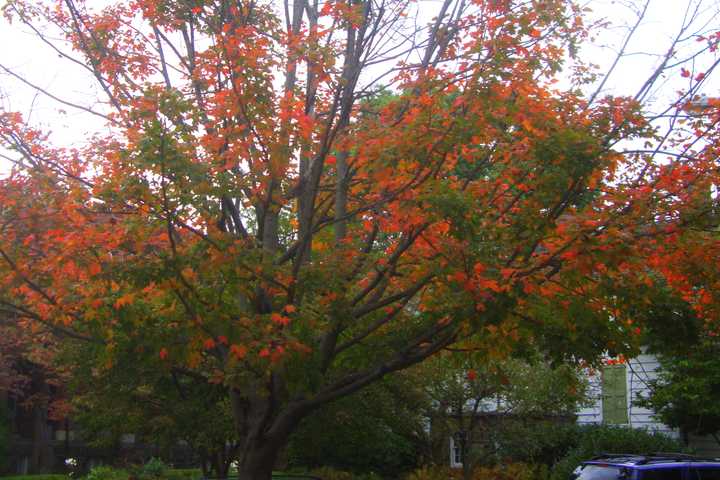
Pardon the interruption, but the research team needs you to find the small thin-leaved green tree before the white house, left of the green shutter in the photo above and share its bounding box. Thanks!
[422,357,587,479]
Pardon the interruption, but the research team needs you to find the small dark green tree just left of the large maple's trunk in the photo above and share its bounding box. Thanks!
[64,345,238,478]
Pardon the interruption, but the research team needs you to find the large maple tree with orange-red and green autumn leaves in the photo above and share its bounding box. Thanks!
[0,0,720,479]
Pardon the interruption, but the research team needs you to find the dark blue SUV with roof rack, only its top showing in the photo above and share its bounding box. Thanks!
[570,453,720,480]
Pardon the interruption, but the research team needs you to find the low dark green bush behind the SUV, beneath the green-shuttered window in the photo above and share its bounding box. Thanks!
[550,425,684,480]
